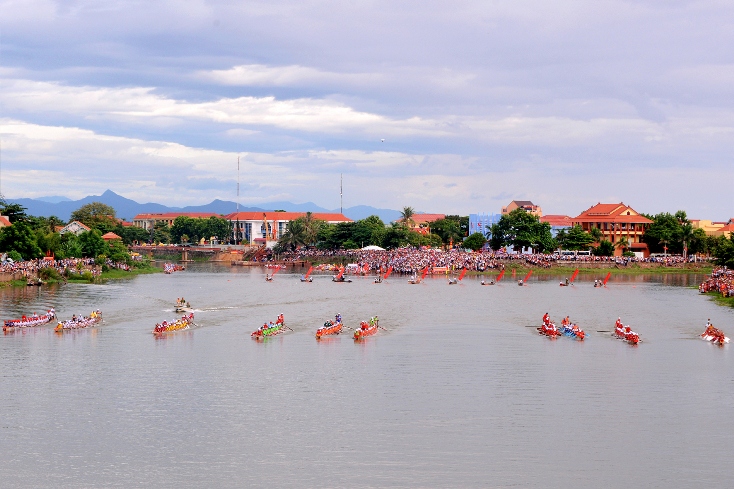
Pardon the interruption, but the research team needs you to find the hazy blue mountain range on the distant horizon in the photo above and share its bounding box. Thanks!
[10,190,400,223]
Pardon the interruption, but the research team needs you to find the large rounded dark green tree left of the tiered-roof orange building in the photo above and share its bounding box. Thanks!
[489,209,555,251]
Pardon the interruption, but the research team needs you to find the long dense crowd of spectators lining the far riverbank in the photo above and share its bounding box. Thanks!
[273,248,712,274]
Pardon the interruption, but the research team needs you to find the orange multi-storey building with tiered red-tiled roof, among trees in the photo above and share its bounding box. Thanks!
[571,202,652,256]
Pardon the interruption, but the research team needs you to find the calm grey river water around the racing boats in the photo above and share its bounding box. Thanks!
[0,264,734,488]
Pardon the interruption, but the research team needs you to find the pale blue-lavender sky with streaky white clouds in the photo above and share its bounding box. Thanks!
[0,0,734,220]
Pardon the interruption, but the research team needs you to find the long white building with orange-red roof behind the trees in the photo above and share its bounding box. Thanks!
[224,211,352,246]
